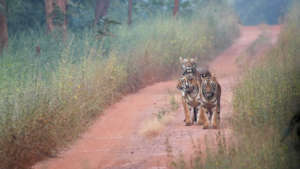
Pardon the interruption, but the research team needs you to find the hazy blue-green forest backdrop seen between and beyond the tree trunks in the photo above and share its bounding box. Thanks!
[0,0,292,33]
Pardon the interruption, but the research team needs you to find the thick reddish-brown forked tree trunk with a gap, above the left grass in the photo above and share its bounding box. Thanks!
[45,0,68,41]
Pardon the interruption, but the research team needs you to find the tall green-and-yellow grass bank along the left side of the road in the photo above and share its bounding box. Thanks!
[0,9,238,169]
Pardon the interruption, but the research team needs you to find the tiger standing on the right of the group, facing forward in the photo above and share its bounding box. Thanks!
[200,73,221,129]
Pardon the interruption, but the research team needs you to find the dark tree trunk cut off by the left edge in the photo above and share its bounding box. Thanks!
[0,0,8,52]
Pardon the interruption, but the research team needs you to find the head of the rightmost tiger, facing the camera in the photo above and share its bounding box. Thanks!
[201,76,218,101]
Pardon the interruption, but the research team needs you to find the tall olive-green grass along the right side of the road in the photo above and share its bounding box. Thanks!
[173,3,300,169]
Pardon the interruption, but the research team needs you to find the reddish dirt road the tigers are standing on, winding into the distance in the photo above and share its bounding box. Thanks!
[34,26,279,169]
